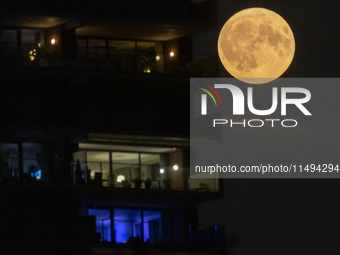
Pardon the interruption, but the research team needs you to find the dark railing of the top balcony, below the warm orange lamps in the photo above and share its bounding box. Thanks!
[0,44,218,77]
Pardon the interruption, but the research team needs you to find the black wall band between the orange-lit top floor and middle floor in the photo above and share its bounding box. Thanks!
[0,67,189,135]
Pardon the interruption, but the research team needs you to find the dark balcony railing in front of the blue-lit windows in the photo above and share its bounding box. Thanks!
[89,220,225,254]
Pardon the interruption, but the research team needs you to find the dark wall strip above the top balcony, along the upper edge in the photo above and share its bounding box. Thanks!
[0,0,191,19]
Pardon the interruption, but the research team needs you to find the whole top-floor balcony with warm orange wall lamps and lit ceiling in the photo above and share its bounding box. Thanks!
[0,0,216,77]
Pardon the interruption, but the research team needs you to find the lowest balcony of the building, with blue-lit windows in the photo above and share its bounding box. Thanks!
[0,182,225,254]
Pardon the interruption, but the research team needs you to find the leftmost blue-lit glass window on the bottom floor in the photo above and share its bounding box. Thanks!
[88,209,111,242]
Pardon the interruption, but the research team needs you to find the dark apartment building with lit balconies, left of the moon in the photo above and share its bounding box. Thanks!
[0,0,224,254]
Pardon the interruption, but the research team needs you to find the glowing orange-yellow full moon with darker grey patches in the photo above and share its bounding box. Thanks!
[218,8,295,84]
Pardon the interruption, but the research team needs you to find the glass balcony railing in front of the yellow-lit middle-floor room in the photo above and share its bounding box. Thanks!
[72,161,219,192]
